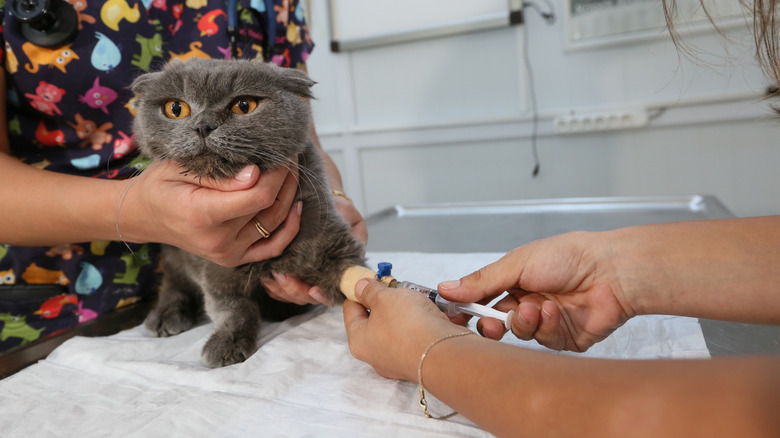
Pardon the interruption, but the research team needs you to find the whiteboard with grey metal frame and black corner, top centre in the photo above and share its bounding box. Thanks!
[329,0,522,52]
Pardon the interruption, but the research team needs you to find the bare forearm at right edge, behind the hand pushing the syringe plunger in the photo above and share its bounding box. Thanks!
[604,216,780,324]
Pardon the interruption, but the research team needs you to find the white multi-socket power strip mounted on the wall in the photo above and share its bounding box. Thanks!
[553,108,650,134]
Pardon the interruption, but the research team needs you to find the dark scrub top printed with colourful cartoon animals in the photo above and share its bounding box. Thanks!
[0,0,314,352]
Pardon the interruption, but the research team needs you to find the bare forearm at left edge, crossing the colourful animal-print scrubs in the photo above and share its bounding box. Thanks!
[0,153,122,246]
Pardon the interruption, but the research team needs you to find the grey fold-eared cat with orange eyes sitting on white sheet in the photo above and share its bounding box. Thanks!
[131,59,364,368]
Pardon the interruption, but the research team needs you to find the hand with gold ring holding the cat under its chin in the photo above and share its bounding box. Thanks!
[116,161,301,266]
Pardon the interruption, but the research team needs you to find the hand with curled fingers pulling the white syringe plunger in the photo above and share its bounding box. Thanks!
[439,232,635,352]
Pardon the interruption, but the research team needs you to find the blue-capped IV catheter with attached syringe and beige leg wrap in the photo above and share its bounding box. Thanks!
[340,263,515,330]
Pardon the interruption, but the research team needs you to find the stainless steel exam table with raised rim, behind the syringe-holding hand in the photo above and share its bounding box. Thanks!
[366,195,780,356]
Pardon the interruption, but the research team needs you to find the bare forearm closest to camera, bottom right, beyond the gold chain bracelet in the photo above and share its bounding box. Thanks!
[426,336,780,437]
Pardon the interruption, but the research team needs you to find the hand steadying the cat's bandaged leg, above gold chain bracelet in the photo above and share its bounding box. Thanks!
[343,280,464,382]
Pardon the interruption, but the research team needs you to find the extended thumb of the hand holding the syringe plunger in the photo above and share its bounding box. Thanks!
[438,248,525,303]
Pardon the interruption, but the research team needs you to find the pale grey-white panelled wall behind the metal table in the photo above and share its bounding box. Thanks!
[308,0,780,216]
